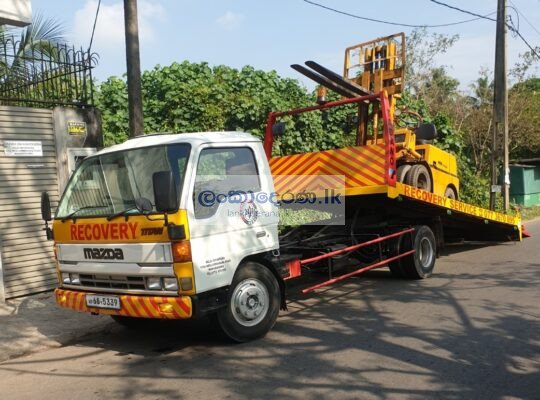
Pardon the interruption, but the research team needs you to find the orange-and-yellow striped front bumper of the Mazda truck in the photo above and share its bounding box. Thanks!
[54,289,193,319]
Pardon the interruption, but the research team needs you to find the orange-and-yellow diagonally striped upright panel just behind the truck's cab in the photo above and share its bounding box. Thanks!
[270,144,385,194]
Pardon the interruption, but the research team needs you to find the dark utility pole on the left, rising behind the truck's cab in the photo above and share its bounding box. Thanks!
[124,0,144,138]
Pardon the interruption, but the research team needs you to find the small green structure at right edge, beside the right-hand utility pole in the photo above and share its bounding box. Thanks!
[510,158,540,207]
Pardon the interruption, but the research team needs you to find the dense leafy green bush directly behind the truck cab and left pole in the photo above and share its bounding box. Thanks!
[97,61,312,148]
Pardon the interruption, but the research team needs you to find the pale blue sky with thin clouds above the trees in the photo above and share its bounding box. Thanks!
[28,0,540,90]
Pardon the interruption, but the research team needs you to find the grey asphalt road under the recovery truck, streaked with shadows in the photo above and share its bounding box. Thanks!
[0,220,540,400]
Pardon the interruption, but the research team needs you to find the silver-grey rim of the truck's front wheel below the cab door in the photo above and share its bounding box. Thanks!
[231,279,270,326]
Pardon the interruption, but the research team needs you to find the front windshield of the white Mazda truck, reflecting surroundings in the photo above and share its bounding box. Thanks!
[55,144,190,218]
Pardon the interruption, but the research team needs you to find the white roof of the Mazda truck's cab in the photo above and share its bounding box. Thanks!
[96,131,260,155]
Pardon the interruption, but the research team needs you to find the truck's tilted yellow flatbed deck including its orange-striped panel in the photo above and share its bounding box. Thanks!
[270,144,522,241]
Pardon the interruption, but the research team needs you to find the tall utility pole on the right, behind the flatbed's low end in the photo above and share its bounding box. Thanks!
[489,0,510,211]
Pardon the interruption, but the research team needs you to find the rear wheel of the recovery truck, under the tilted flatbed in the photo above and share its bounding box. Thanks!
[396,225,437,279]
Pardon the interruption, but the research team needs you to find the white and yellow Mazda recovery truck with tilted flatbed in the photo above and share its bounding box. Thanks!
[42,95,522,341]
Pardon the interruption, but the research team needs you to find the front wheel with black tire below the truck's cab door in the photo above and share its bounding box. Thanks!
[217,262,281,343]
